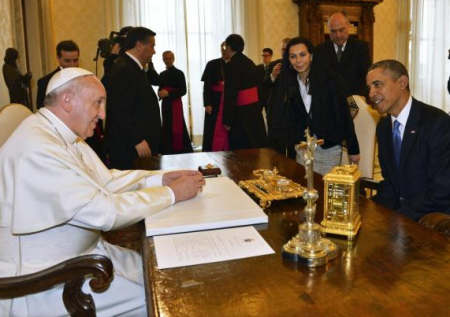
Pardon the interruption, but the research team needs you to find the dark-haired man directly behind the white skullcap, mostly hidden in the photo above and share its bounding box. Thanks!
[36,40,80,109]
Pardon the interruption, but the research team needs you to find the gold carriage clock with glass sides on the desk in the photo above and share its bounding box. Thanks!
[322,165,361,240]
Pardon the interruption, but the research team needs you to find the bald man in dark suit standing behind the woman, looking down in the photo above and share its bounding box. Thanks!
[314,10,372,96]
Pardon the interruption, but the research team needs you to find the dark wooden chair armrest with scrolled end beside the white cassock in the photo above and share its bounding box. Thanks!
[0,254,113,317]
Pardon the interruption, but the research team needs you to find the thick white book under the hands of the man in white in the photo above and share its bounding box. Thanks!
[145,177,268,236]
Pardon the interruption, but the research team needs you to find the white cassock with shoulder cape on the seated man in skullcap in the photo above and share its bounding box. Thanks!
[0,108,173,317]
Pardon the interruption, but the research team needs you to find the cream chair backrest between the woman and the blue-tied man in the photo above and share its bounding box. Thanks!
[342,95,380,179]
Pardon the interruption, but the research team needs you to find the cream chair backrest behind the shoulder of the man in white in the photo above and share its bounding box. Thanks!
[0,103,33,147]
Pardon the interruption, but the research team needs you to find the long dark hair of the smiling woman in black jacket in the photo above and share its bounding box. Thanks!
[281,37,314,98]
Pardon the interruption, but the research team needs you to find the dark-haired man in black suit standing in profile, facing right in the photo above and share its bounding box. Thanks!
[105,27,161,169]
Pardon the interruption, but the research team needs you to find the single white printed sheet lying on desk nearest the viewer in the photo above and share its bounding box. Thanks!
[154,227,275,269]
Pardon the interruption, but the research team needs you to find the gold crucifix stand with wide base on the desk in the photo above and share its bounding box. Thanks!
[282,129,338,267]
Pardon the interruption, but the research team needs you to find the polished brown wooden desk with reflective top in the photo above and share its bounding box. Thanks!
[134,149,450,317]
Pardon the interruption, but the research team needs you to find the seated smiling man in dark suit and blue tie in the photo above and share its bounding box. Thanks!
[367,60,450,221]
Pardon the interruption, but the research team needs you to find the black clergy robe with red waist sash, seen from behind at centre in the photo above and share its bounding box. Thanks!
[222,53,267,150]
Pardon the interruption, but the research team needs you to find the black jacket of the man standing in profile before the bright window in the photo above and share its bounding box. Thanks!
[104,54,161,161]
